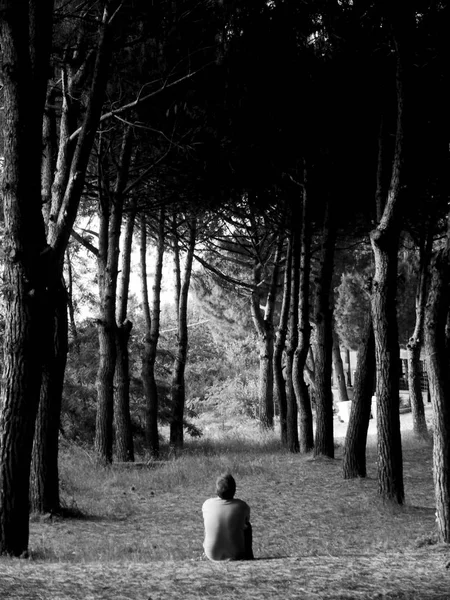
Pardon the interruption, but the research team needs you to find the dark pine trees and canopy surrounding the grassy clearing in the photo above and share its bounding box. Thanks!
[0,0,450,568]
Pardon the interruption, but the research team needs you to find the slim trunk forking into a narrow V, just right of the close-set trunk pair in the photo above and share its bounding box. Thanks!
[140,208,165,458]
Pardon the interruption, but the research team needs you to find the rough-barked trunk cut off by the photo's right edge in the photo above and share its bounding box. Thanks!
[425,247,450,544]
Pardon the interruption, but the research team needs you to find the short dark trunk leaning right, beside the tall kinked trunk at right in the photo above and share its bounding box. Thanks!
[342,312,375,479]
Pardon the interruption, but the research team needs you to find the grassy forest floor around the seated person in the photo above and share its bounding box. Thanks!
[0,406,450,600]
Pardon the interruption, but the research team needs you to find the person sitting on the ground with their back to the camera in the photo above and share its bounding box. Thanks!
[202,473,253,560]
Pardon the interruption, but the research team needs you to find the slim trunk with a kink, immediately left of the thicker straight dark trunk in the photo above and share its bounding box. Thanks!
[292,176,314,454]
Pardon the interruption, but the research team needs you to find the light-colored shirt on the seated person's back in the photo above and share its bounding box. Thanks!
[202,497,250,560]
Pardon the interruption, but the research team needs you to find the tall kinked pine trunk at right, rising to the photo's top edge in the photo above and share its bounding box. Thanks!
[370,6,414,504]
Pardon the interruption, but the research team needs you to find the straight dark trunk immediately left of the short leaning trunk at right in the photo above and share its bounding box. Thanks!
[314,202,336,458]
